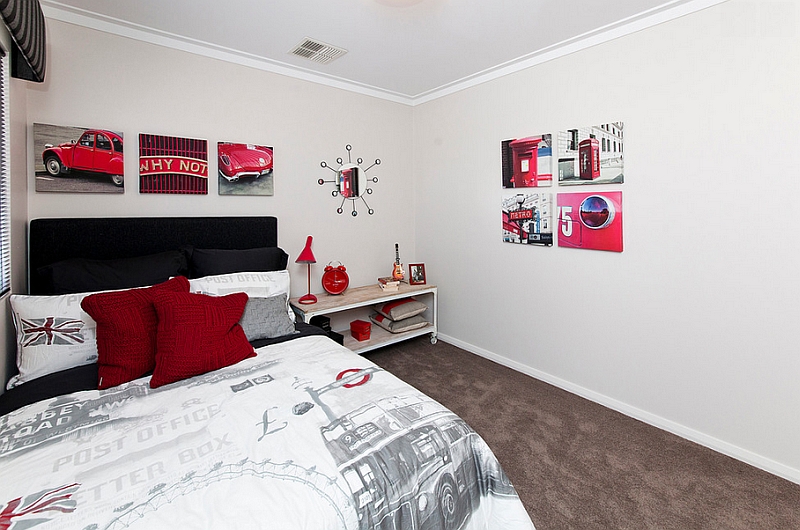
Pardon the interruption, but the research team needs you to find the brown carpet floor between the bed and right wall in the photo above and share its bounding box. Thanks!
[366,337,800,530]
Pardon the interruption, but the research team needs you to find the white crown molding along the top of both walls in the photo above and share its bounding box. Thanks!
[40,0,728,106]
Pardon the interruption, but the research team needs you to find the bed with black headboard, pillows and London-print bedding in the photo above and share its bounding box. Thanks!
[0,217,533,530]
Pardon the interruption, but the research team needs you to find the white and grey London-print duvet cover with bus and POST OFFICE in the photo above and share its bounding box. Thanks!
[0,336,533,530]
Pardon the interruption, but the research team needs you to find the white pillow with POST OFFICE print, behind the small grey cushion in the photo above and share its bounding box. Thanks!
[189,271,295,322]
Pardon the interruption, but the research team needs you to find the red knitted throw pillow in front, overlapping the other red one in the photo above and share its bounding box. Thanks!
[150,293,256,388]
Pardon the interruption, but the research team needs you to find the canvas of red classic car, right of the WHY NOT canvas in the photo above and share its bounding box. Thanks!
[217,142,275,195]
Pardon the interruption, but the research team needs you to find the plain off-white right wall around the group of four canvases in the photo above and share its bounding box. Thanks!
[414,0,800,482]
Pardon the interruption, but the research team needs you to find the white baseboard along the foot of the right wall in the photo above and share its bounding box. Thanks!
[438,333,800,484]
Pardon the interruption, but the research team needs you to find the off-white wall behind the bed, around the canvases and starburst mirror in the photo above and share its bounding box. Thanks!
[27,19,414,295]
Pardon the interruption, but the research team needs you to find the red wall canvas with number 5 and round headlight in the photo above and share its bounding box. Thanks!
[558,191,622,252]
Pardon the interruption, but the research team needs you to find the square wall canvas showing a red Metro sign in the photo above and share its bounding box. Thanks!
[502,193,553,247]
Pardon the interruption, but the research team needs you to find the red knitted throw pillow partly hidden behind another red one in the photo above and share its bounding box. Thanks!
[81,276,189,389]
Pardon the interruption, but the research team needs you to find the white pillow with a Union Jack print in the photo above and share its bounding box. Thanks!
[6,293,97,390]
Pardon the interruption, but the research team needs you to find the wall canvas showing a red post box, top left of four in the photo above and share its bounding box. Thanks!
[500,134,553,188]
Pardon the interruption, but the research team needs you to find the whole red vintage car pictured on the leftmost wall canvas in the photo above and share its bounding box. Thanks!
[42,129,125,186]
